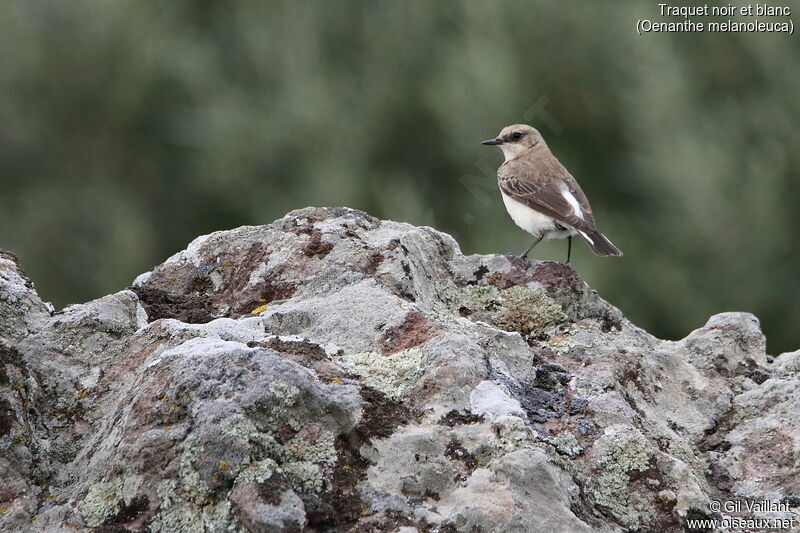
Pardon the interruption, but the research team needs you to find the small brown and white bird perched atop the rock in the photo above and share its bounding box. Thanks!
[482,124,622,263]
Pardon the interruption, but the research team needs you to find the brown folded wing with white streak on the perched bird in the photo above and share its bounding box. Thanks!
[497,161,597,231]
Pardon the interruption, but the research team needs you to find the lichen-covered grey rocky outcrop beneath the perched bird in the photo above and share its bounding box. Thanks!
[0,208,800,533]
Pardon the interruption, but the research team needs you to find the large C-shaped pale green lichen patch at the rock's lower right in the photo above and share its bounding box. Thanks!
[593,433,654,528]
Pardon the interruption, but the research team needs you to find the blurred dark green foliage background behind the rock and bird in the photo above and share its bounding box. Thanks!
[0,0,800,352]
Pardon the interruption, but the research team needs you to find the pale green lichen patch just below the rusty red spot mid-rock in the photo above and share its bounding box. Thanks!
[342,349,422,398]
